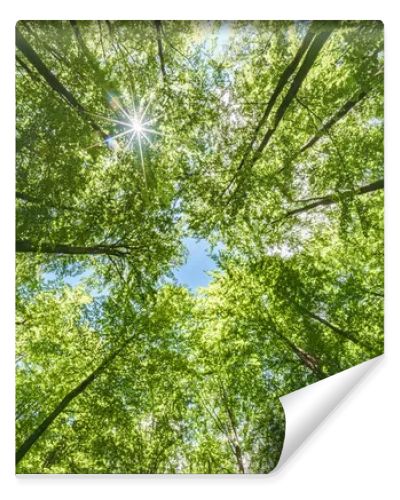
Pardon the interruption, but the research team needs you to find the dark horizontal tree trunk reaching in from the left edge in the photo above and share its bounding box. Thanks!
[16,240,129,257]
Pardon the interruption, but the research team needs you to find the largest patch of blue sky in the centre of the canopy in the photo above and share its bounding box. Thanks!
[174,238,217,290]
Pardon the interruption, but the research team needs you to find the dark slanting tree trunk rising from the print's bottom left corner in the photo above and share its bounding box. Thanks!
[16,335,134,464]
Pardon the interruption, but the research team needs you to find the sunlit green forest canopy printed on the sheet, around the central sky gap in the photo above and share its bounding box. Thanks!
[16,21,383,473]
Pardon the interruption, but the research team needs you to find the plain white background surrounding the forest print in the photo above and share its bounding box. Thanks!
[0,0,400,500]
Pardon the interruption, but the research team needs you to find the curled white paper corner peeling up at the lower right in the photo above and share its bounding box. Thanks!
[272,354,383,473]
